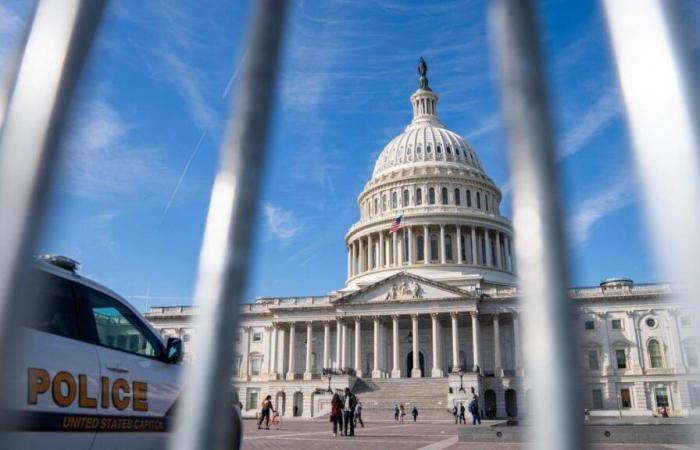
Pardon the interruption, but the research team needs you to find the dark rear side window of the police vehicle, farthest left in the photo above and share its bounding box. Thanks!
[25,272,78,339]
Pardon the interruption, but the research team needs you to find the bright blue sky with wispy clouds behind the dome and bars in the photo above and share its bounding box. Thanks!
[0,0,697,309]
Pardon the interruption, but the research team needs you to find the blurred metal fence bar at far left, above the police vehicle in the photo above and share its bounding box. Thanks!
[0,0,105,412]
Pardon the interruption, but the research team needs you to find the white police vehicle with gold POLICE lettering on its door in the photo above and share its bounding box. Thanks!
[5,255,183,450]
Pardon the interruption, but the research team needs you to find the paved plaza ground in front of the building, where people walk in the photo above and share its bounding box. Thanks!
[243,418,696,450]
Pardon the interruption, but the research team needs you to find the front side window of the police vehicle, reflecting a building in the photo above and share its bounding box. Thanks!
[84,288,160,357]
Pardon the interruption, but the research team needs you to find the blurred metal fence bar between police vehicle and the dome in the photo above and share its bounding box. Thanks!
[170,0,286,450]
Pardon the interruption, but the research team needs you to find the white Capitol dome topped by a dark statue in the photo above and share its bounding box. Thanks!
[345,58,515,290]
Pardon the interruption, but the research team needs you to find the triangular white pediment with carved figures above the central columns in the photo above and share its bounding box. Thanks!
[335,272,475,304]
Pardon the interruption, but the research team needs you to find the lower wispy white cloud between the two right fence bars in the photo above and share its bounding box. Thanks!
[569,173,635,246]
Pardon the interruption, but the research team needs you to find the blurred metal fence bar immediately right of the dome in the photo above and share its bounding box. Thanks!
[491,0,583,450]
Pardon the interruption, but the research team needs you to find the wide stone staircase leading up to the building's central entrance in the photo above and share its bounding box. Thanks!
[353,378,454,421]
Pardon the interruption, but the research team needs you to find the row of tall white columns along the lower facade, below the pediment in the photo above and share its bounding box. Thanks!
[264,311,522,380]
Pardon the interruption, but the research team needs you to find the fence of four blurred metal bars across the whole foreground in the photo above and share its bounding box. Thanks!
[0,0,700,450]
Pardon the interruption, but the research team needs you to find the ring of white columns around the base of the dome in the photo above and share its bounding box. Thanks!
[347,224,515,278]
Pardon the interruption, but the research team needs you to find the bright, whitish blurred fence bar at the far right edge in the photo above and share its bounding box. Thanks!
[603,0,700,370]
